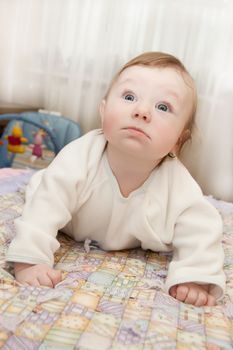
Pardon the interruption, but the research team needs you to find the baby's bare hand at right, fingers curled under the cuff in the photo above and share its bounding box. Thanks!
[169,282,216,306]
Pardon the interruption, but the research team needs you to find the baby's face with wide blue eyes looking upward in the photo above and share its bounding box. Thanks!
[100,66,193,161]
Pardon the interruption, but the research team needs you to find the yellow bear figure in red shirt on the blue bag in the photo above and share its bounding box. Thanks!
[5,123,28,153]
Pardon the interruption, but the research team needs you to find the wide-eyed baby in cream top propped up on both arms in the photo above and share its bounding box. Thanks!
[7,52,225,306]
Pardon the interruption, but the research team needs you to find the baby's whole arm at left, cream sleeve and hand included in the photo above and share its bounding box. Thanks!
[6,130,103,286]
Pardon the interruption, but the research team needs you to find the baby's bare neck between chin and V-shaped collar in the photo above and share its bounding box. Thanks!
[106,147,157,197]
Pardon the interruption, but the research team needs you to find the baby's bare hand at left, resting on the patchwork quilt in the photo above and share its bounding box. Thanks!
[14,262,61,288]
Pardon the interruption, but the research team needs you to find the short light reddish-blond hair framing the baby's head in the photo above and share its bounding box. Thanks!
[105,51,197,132]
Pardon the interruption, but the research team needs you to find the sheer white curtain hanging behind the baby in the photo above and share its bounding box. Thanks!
[0,0,233,201]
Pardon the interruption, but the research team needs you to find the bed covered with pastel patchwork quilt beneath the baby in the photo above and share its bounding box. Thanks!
[0,168,233,350]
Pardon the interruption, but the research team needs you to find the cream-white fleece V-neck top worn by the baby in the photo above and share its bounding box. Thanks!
[6,130,225,298]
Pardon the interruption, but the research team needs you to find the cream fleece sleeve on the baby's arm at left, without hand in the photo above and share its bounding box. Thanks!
[6,131,104,266]
